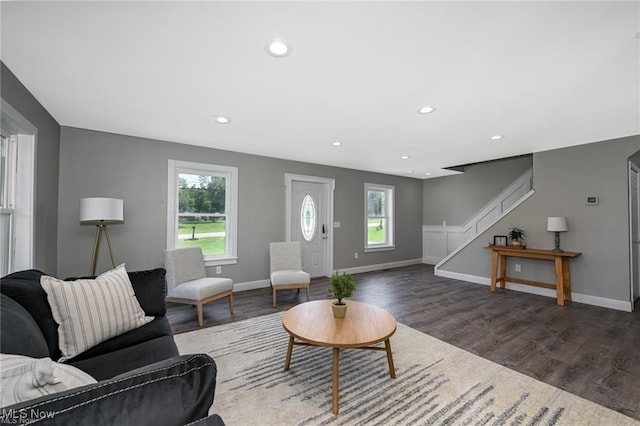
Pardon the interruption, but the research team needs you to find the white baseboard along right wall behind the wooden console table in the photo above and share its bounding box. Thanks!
[436,269,633,312]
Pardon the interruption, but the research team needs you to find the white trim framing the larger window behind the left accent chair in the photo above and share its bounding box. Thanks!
[167,160,238,266]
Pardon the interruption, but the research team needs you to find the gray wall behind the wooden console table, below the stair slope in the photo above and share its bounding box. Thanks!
[441,136,640,301]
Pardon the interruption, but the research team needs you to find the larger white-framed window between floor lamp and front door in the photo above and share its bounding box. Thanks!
[167,160,238,266]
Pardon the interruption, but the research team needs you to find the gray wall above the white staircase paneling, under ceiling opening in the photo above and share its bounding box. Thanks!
[422,155,532,226]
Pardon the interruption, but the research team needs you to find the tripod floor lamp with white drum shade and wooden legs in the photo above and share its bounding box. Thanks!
[80,197,124,275]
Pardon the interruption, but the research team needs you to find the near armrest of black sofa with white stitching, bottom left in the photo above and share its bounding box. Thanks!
[4,354,216,426]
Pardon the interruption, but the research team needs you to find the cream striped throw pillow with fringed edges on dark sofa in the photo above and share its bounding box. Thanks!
[40,264,153,361]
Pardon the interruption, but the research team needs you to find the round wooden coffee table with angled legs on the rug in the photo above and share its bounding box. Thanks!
[282,300,397,414]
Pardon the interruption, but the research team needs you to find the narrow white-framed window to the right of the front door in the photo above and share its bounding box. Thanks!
[364,183,394,251]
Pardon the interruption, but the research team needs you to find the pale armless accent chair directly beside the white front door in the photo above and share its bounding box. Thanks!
[269,241,311,308]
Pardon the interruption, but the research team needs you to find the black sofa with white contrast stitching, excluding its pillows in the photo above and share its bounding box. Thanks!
[0,268,224,425]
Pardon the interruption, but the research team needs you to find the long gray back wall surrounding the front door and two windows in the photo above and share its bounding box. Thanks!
[58,127,422,283]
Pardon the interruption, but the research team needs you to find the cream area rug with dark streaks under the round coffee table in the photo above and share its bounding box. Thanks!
[175,313,640,426]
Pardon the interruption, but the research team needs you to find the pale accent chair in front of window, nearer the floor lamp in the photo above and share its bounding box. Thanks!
[162,247,233,327]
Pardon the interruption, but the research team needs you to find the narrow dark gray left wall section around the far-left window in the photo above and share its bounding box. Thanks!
[0,62,60,274]
